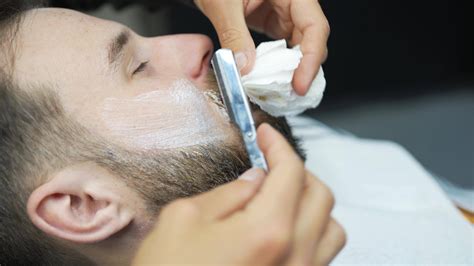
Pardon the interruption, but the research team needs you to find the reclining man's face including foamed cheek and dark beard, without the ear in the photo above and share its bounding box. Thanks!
[13,9,304,217]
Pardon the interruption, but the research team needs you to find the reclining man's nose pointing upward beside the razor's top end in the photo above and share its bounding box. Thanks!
[150,34,214,82]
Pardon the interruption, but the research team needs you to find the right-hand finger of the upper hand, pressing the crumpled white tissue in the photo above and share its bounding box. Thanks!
[291,0,329,95]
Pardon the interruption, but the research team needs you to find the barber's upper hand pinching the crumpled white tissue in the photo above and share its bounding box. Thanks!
[194,0,329,95]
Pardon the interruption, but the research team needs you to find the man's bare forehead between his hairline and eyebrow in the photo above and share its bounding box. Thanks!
[15,8,122,83]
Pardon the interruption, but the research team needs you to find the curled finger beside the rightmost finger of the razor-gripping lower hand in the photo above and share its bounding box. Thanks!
[289,172,334,265]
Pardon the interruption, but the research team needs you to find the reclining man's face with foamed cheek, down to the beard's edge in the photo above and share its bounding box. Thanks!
[15,9,238,150]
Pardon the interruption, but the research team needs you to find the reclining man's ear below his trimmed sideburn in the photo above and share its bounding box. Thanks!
[27,163,135,243]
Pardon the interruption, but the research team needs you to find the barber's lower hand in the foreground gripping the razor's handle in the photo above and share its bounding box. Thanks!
[134,124,345,265]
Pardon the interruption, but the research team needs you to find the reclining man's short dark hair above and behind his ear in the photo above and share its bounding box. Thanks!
[0,0,90,266]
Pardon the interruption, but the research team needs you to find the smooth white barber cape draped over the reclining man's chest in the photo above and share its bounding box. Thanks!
[290,117,474,265]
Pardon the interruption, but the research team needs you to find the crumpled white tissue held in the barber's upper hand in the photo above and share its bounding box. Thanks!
[242,40,326,116]
